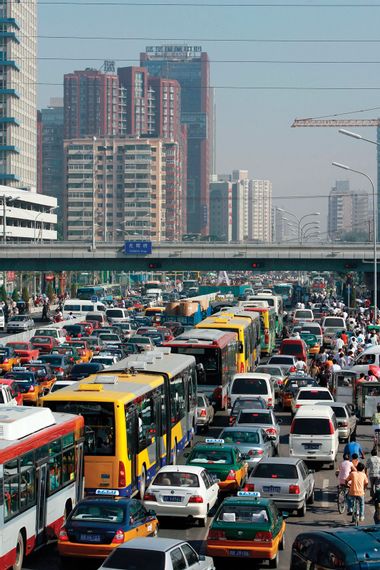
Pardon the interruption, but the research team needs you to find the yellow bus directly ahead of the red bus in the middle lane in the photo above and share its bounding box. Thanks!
[195,315,254,372]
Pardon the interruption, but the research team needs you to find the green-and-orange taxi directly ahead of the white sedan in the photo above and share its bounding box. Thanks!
[185,439,248,491]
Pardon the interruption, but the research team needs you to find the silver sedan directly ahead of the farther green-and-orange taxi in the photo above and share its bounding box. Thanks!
[219,427,274,470]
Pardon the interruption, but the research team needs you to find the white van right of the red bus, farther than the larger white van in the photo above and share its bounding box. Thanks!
[228,372,275,408]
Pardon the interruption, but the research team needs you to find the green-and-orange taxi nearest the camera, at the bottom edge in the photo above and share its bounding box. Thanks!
[207,491,286,568]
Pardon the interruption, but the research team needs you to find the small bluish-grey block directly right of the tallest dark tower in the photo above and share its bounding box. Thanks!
[210,181,232,242]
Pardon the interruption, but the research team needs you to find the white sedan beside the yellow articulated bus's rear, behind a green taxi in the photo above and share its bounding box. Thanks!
[144,465,219,526]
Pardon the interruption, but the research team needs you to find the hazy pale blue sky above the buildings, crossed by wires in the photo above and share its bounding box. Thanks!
[38,0,380,235]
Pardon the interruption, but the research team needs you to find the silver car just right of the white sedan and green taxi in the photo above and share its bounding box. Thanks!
[246,457,315,517]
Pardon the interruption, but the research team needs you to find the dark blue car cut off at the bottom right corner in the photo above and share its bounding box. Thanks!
[290,525,380,570]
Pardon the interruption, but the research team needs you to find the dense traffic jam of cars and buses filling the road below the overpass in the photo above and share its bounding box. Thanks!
[0,272,380,570]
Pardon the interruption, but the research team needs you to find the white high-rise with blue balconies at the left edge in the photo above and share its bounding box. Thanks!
[0,0,37,190]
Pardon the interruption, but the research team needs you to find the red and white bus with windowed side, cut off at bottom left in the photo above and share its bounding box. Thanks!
[0,406,84,570]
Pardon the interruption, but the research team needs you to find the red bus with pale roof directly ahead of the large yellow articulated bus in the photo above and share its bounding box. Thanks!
[164,329,238,409]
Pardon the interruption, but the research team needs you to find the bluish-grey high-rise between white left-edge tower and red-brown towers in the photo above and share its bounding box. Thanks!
[37,98,64,208]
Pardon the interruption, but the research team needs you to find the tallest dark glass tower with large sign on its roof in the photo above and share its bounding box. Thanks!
[140,41,213,235]
